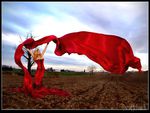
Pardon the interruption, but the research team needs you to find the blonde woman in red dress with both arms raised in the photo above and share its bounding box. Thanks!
[27,43,49,89]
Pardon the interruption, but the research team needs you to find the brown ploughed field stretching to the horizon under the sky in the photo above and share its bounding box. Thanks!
[1,70,149,109]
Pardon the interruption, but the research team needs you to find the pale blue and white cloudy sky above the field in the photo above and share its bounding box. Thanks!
[2,2,148,71]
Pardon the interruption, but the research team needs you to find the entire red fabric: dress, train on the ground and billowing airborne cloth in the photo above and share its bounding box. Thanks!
[14,31,141,98]
